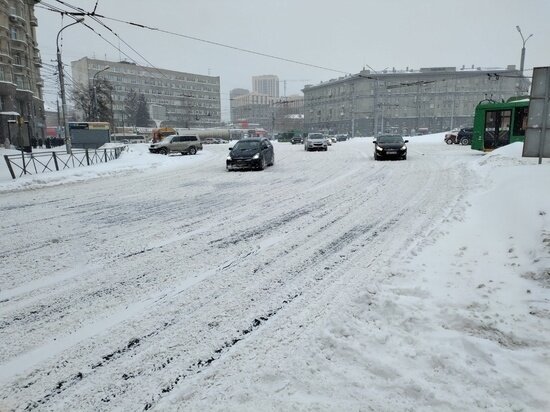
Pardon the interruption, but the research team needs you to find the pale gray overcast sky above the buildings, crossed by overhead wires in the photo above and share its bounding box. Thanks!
[35,0,550,117]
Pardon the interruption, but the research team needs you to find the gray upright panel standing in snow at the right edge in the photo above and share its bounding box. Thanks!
[523,67,550,164]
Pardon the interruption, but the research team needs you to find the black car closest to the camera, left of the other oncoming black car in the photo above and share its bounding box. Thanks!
[226,137,275,171]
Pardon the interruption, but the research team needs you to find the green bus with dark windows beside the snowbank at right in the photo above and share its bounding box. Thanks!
[472,97,529,152]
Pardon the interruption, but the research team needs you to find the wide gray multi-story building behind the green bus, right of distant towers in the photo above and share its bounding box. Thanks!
[303,66,529,136]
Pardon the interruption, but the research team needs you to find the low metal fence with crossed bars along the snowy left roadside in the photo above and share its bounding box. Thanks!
[4,146,126,179]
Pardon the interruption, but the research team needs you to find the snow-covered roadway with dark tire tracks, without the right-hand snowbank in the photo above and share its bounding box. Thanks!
[0,138,543,411]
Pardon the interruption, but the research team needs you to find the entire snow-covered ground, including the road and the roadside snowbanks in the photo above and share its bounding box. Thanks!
[0,135,550,411]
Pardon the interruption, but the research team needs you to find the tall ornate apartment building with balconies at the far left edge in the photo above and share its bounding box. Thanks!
[0,0,46,147]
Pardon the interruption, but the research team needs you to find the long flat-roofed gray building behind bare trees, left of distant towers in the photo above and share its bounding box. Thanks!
[71,57,221,127]
